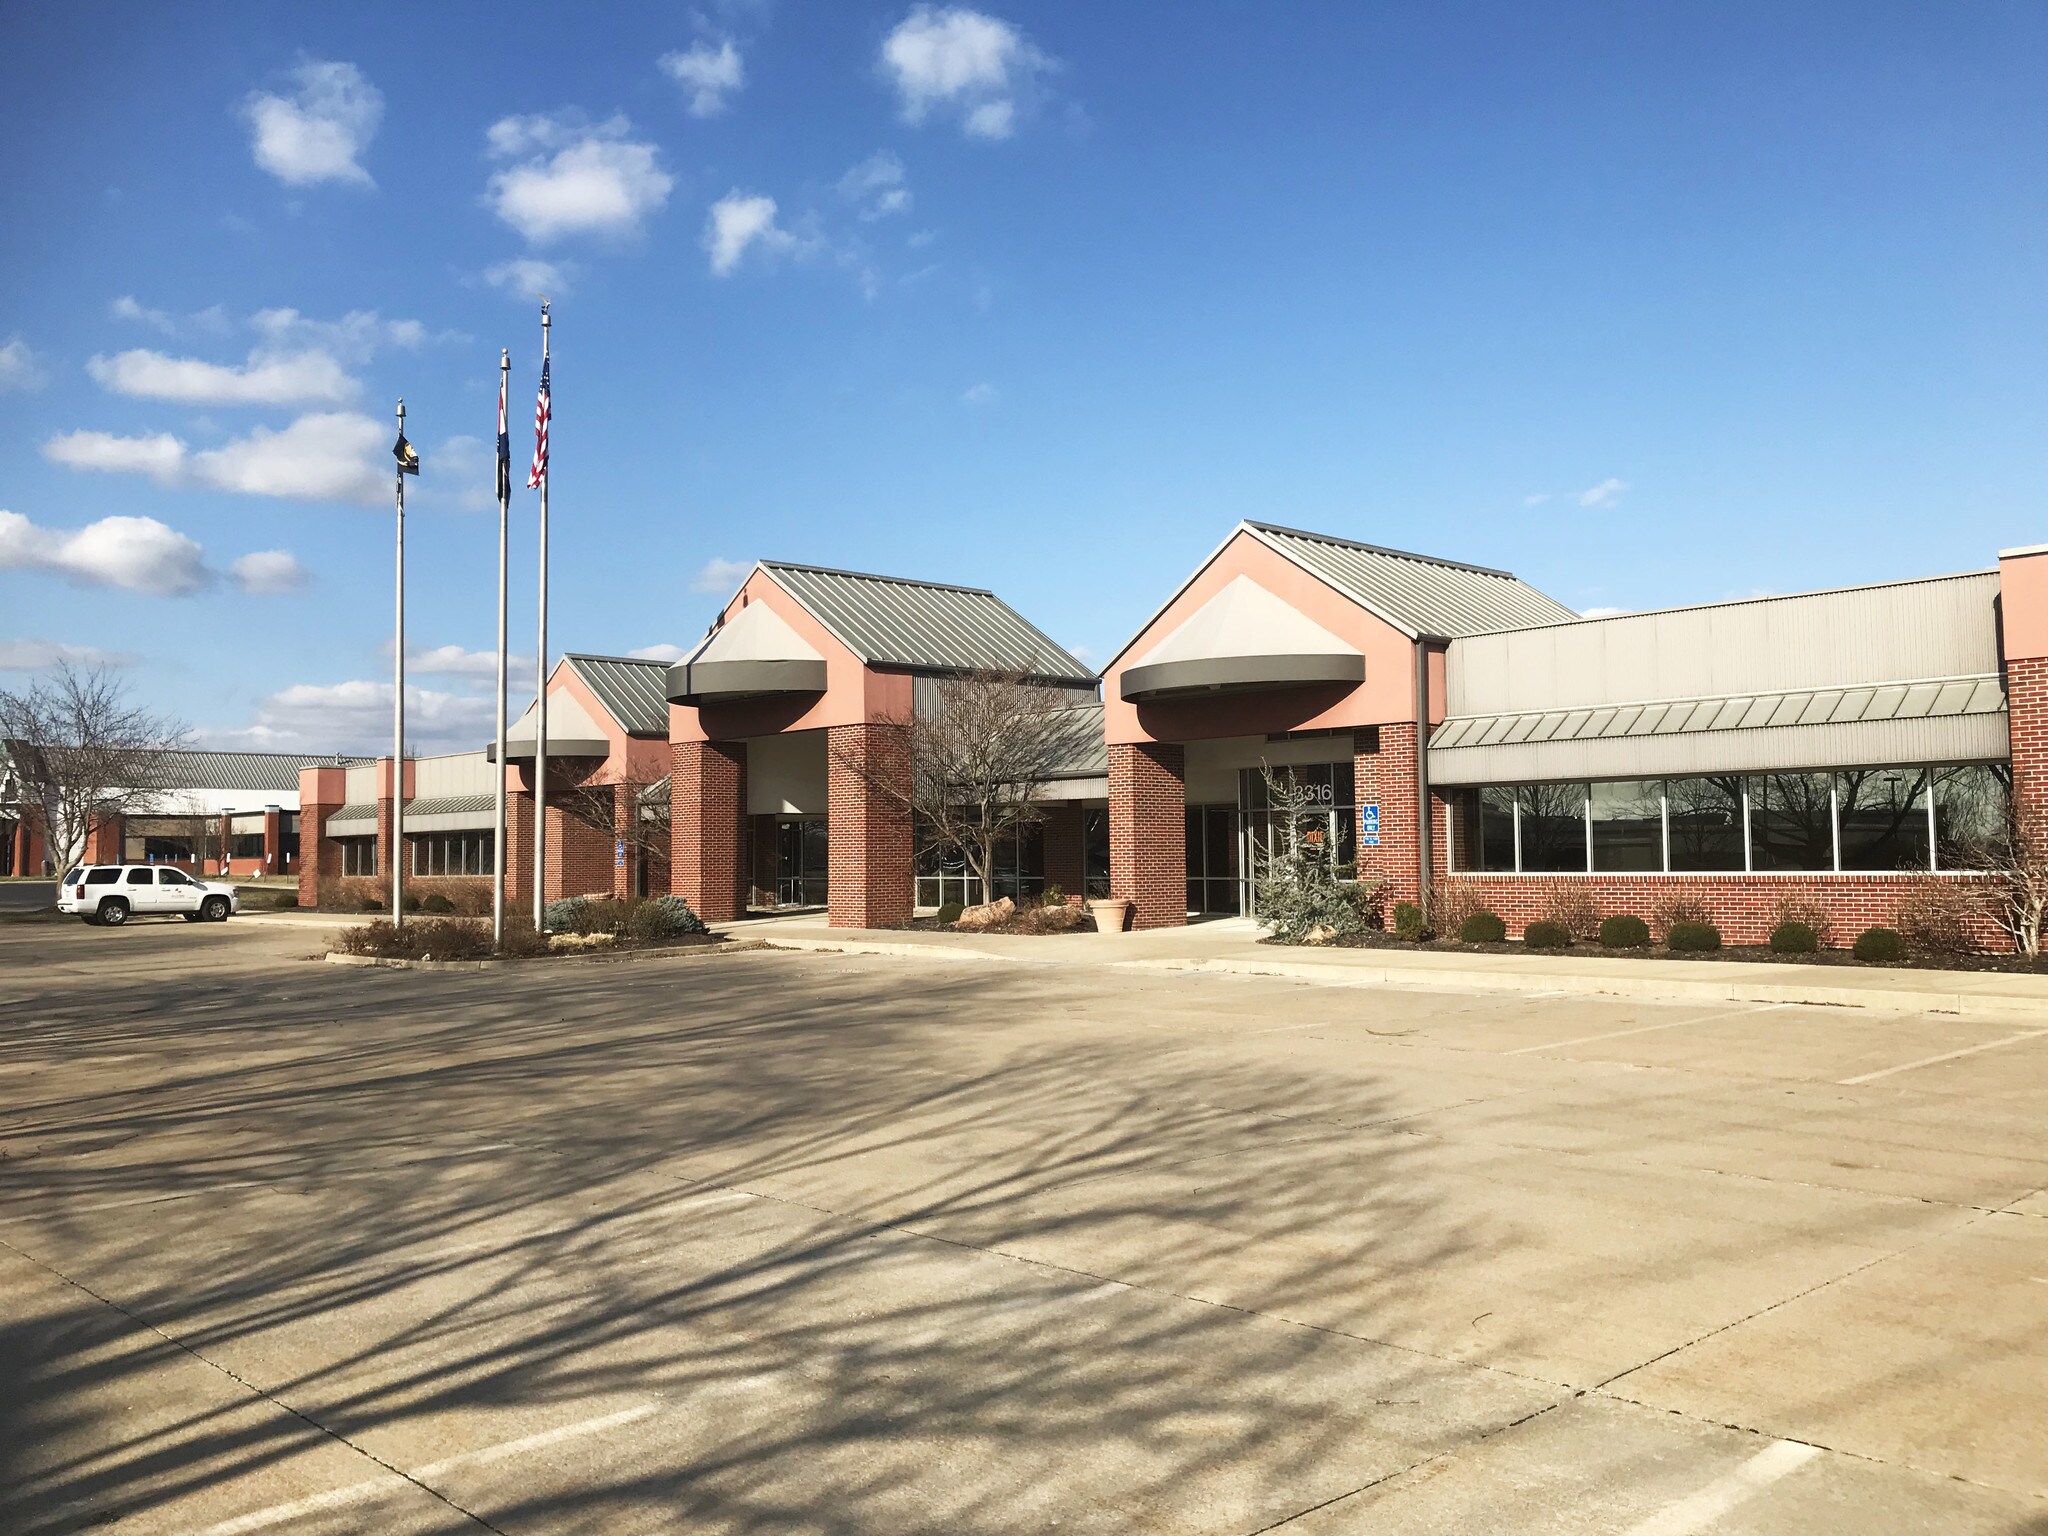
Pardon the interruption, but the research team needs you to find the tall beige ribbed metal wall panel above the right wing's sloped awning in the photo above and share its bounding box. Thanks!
[1446,571,1999,715]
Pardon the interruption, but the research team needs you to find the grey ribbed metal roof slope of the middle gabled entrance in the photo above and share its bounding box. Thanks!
[762,559,1096,686]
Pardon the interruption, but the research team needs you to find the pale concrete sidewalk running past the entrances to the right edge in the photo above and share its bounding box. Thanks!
[715,913,2048,1028]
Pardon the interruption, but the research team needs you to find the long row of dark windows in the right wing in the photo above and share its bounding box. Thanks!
[1452,764,2013,874]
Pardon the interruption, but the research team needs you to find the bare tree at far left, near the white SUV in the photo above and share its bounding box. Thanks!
[0,662,184,870]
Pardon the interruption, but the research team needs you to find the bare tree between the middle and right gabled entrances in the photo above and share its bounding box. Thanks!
[838,672,1100,899]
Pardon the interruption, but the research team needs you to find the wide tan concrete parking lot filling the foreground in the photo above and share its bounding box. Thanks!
[0,920,2048,1536]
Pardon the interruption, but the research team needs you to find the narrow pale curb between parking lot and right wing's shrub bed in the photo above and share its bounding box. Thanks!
[1112,961,2044,1020]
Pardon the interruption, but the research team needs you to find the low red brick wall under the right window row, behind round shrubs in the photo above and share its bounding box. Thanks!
[1448,874,2011,950]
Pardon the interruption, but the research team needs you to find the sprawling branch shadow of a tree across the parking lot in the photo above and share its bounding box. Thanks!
[0,954,1523,1532]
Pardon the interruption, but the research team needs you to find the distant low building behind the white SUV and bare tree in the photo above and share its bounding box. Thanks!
[0,748,356,879]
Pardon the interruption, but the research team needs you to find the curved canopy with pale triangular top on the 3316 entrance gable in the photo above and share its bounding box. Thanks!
[1122,575,1366,702]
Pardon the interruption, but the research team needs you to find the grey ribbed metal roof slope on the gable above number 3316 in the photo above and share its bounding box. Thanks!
[1239,520,1579,639]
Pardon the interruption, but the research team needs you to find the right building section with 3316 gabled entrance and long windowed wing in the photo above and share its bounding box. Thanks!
[1104,522,2048,942]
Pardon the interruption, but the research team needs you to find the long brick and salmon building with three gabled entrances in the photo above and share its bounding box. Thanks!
[288,522,2048,942]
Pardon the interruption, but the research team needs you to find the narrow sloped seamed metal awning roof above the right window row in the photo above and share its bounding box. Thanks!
[1430,676,2005,752]
